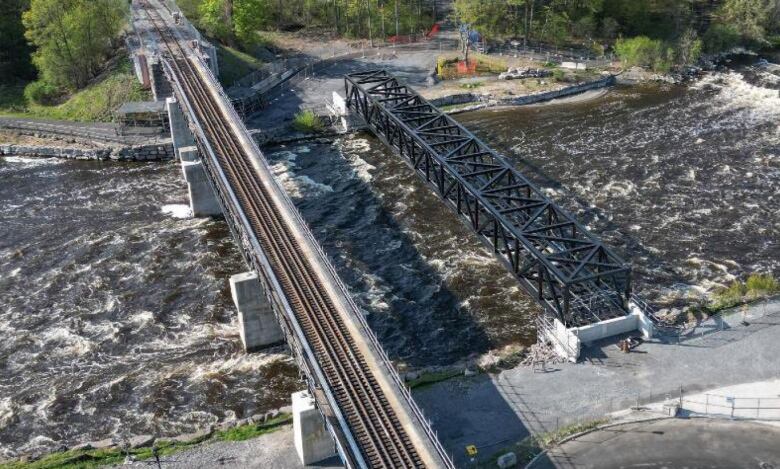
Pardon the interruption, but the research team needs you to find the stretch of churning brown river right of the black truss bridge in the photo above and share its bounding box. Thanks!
[461,70,780,306]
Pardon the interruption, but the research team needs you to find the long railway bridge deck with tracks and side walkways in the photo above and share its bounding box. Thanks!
[141,0,454,469]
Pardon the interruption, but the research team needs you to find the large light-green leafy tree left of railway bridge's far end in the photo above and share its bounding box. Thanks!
[22,0,128,90]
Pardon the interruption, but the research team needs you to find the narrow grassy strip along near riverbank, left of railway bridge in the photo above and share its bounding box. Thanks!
[0,414,292,469]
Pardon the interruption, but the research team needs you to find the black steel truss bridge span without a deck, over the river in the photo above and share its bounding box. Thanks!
[344,70,632,327]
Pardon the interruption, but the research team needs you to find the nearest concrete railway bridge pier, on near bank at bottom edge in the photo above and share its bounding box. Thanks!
[292,391,336,466]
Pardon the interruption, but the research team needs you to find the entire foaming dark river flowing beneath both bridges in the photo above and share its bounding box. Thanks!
[0,62,780,455]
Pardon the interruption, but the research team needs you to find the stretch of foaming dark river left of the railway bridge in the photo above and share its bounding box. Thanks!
[0,158,300,456]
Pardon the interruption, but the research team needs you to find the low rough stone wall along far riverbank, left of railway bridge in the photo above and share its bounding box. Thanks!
[0,143,174,161]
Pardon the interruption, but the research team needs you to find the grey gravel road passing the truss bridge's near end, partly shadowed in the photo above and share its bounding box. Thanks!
[415,302,780,469]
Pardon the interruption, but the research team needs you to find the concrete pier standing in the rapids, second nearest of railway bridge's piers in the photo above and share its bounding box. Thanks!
[230,272,284,352]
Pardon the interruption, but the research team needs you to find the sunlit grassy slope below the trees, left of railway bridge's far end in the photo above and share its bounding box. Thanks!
[0,60,150,122]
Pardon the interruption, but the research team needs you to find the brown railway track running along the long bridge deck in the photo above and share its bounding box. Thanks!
[143,0,425,468]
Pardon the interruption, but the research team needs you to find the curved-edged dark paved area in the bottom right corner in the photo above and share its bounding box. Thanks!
[529,419,780,469]
